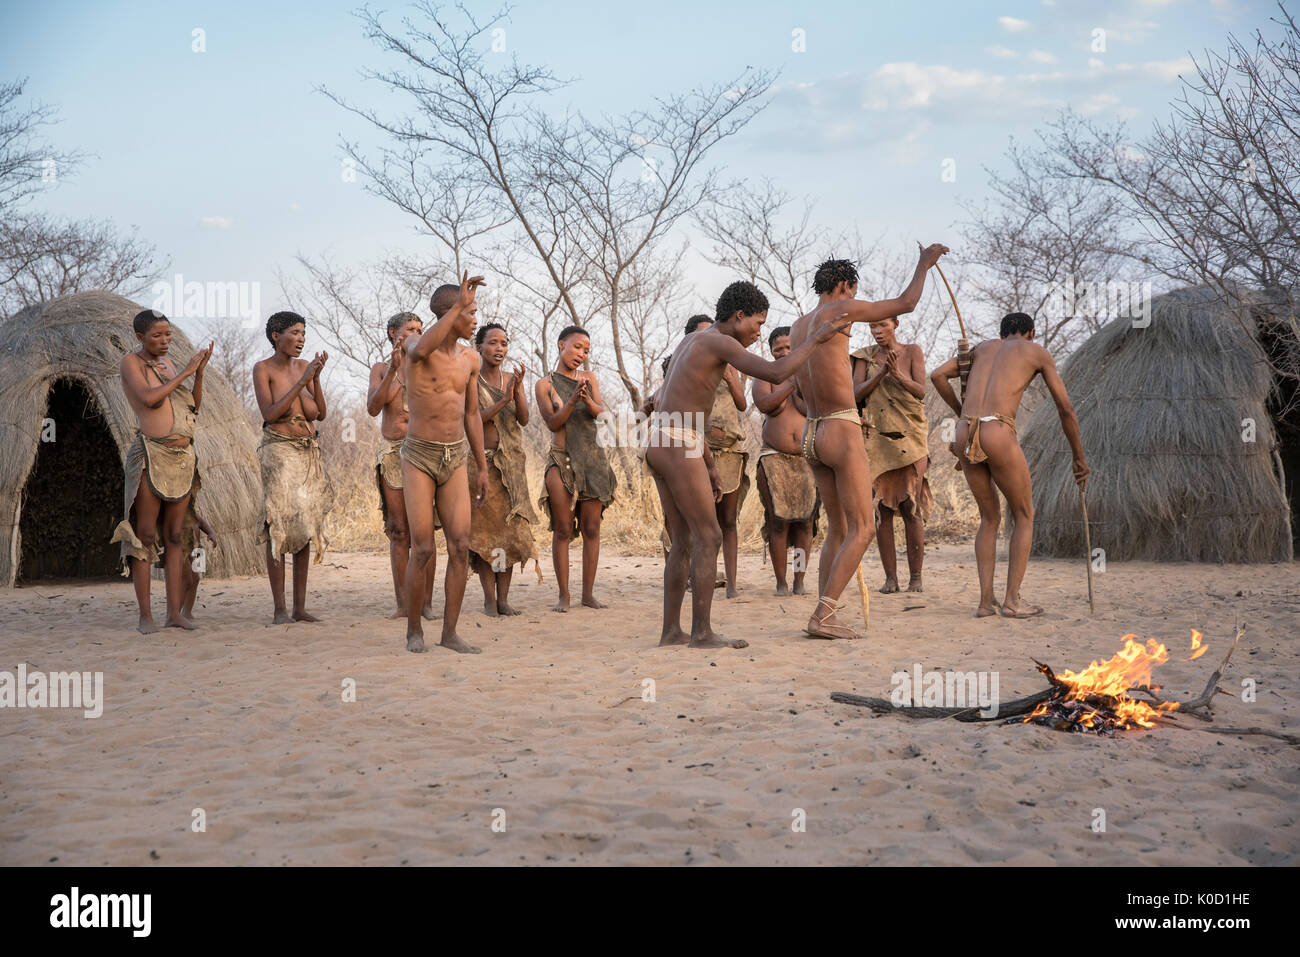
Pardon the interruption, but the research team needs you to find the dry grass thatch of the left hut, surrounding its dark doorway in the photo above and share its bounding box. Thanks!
[0,291,263,586]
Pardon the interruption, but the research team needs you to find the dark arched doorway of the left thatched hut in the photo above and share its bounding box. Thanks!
[18,378,124,583]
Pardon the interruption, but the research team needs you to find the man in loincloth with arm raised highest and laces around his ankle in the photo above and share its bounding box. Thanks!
[790,243,948,638]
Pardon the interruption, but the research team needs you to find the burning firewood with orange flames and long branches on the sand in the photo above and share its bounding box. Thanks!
[831,628,1300,746]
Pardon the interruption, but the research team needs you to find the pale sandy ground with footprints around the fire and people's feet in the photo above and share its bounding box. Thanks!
[0,545,1300,866]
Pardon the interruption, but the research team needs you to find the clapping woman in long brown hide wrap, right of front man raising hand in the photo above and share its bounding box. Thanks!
[469,322,541,618]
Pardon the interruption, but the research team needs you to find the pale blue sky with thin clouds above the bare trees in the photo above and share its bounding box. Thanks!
[0,0,1275,361]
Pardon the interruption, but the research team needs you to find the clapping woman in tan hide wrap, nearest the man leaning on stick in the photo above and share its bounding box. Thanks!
[853,317,933,594]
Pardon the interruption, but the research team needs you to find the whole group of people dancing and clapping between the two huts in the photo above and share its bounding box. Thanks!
[113,244,1087,653]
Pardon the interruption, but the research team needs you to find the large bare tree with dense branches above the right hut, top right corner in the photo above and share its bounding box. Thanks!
[1050,3,1300,382]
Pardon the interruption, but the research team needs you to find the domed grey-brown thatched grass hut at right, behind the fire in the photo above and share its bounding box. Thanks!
[1021,286,1300,562]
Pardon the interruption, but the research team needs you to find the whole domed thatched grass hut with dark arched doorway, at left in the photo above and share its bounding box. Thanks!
[0,293,263,586]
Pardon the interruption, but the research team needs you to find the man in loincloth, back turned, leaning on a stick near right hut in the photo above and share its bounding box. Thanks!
[930,312,1088,618]
